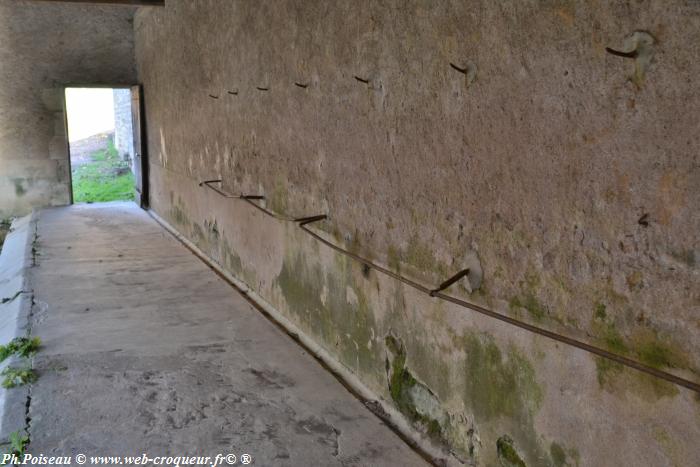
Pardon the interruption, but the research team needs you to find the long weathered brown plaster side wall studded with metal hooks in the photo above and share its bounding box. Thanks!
[135,0,700,466]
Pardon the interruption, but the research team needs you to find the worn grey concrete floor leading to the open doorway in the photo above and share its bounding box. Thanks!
[28,203,425,466]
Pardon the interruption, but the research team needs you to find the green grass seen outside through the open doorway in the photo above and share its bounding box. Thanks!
[73,140,134,203]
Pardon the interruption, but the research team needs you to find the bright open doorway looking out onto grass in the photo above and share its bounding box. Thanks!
[65,87,137,203]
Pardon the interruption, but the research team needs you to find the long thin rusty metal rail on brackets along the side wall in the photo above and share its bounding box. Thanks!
[200,180,700,393]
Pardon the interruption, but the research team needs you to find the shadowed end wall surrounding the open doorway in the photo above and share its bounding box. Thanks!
[0,0,136,217]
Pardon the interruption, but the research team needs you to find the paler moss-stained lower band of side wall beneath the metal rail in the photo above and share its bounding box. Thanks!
[152,165,700,466]
